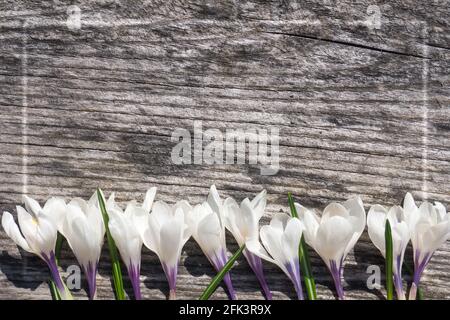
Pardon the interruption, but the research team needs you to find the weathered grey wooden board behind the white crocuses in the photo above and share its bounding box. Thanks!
[0,0,450,299]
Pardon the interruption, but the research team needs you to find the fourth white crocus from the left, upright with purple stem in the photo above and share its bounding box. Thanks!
[143,201,192,299]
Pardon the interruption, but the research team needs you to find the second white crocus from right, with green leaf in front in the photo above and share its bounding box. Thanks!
[367,204,410,300]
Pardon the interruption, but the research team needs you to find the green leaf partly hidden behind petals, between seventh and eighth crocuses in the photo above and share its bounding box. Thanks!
[288,192,317,300]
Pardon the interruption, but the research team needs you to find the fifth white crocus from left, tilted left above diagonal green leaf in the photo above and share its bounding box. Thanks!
[187,198,236,300]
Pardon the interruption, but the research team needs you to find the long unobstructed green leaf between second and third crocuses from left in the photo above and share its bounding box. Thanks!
[97,189,125,300]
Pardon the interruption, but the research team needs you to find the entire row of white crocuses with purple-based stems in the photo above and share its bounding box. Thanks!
[2,186,450,299]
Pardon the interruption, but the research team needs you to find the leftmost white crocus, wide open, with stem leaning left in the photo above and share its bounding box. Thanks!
[2,196,72,299]
